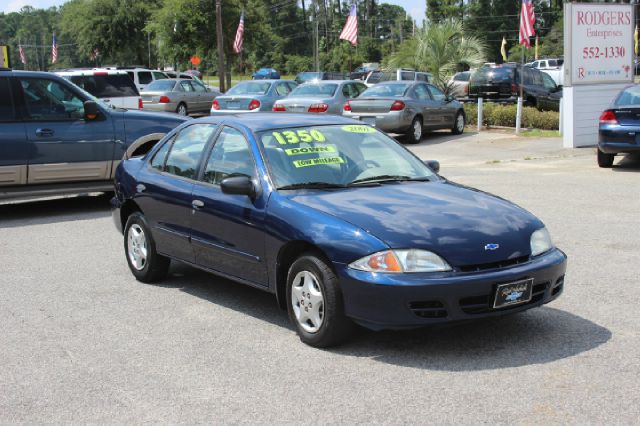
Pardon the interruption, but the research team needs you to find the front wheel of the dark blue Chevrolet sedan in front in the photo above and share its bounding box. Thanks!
[287,254,354,348]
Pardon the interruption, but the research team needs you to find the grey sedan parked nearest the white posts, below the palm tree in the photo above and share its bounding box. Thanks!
[342,81,465,143]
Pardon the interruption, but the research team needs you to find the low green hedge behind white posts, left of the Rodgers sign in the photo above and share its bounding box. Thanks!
[464,102,560,130]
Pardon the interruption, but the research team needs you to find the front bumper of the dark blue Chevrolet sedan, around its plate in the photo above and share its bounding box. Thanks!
[336,249,567,329]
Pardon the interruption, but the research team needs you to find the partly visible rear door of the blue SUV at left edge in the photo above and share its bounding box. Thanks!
[0,77,29,187]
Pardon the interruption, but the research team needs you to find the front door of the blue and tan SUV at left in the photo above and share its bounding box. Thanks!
[18,77,115,184]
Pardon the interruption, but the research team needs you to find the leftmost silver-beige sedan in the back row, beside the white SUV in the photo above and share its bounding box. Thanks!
[140,79,221,115]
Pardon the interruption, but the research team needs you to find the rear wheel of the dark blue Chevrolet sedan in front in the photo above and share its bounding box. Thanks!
[124,212,171,283]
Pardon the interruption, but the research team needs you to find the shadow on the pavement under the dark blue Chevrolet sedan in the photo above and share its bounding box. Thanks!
[160,263,611,371]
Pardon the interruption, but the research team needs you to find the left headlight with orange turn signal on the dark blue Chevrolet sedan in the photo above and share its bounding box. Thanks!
[349,249,451,273]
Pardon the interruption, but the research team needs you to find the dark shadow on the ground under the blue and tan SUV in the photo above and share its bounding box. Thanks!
[0,194,113,228]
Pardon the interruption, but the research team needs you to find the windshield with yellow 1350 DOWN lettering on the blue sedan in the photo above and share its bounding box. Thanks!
[257,124,434,190]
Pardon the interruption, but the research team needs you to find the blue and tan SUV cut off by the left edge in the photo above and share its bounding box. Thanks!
[0,68,186,200]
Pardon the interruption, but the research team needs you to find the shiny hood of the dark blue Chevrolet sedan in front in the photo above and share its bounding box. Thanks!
[282,182,544,266]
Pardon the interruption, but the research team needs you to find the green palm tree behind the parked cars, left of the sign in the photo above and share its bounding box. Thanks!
[387,20,486,92]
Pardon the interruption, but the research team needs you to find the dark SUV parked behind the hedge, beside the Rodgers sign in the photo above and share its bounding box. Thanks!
[469,64,562,111]
